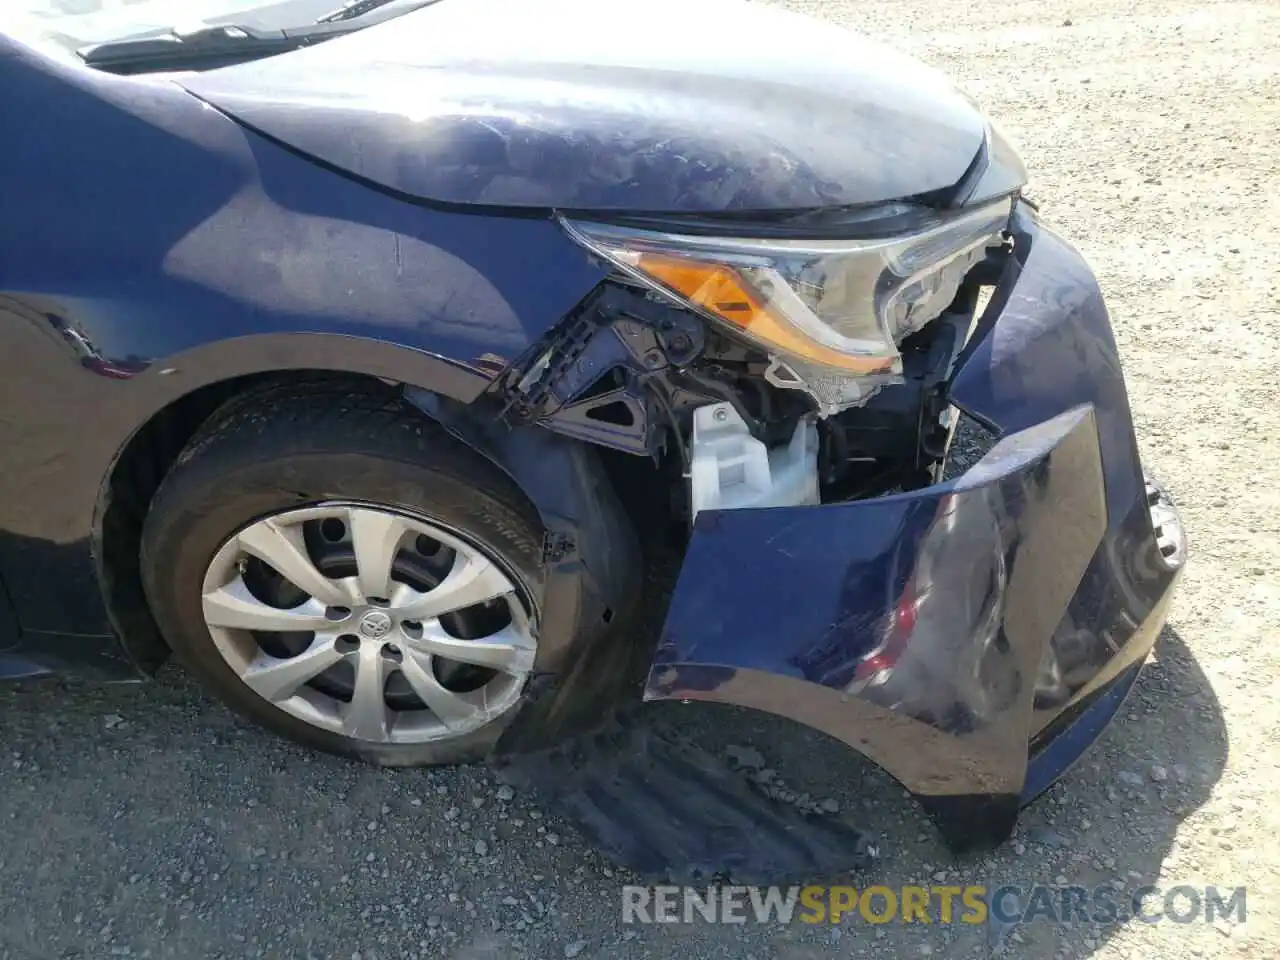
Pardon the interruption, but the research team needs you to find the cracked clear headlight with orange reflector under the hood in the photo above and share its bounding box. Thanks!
[564,197,1012,413]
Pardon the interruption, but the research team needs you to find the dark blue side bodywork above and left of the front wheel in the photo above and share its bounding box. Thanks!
[0,36,602,672]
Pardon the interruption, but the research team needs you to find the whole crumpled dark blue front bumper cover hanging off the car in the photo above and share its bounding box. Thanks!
[645,206,1185,849]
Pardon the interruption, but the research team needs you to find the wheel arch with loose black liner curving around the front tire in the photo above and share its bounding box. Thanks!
[92,334,640,686]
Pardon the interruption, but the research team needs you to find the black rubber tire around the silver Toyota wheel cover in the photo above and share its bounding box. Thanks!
[141,379,543,767]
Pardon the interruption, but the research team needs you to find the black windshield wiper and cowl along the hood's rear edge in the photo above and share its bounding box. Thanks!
[83,0,435,74]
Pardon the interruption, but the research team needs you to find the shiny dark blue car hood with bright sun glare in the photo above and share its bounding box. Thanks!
[177,0,986,214]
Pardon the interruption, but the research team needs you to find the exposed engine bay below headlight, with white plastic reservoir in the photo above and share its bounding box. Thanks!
[503,241,1009,521]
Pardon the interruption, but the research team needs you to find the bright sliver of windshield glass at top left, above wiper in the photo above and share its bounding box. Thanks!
[0,0,394,50]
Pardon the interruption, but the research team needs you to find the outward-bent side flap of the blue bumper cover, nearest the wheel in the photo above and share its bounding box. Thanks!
[648,407,1106,794]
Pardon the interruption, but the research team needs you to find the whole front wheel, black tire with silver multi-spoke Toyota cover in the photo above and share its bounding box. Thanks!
[142,383,541,765]
